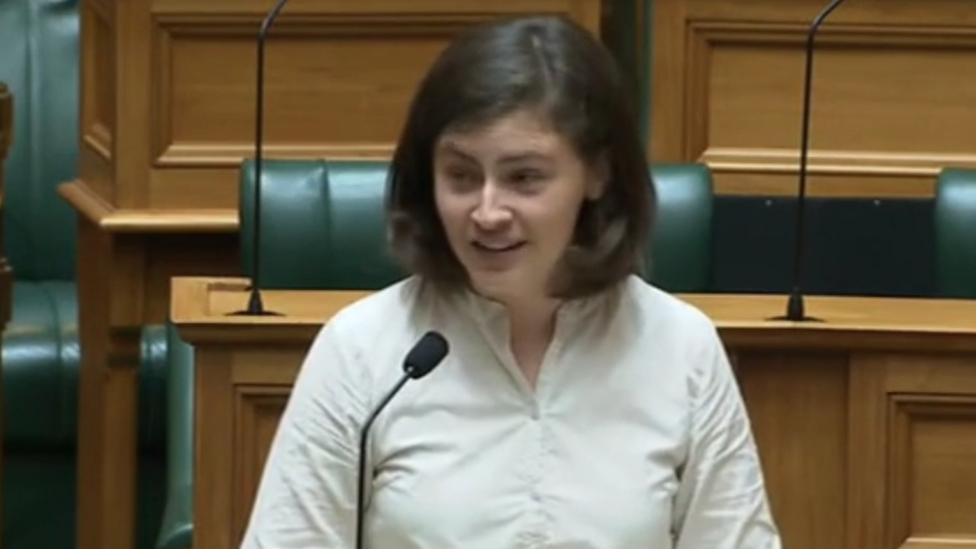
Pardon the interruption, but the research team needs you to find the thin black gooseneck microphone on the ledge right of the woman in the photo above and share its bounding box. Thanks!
[773,0,845,321]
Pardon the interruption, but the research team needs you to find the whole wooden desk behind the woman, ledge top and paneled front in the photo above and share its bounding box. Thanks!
[171,278,976,549]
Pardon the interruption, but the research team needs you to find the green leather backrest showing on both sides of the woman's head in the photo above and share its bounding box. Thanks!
[240,160,712,292]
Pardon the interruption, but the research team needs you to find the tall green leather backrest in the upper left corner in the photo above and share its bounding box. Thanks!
[0,0,79,280]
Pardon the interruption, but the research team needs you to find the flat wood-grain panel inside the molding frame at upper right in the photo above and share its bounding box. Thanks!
[704,30,976,154]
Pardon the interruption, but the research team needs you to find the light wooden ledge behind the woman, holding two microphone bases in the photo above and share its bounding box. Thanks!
[170,277,976,353]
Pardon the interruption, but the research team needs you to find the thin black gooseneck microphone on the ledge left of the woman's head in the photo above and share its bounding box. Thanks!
[233,0,288,316]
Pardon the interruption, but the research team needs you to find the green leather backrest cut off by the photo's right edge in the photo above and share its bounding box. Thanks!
[935,168,976,299]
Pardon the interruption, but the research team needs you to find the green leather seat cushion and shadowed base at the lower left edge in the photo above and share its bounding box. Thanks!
[0,281,78,549]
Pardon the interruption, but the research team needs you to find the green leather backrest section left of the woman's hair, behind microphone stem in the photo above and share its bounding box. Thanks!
[240,160,403,289]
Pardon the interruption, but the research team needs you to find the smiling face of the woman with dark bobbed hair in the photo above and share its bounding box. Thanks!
[434,111,604,303]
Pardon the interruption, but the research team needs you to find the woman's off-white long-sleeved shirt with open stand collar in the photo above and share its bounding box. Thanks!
[242,276,780,549]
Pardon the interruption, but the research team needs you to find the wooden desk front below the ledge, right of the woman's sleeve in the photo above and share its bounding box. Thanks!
[740,348,976,549]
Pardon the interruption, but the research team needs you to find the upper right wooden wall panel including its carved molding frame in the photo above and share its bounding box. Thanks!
[686,21,976,196]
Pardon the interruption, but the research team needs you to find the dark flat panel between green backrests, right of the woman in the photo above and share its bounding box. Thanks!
[714,197,934,296]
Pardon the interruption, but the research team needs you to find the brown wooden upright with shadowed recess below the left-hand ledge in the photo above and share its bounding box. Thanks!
[70,216,239,549]
